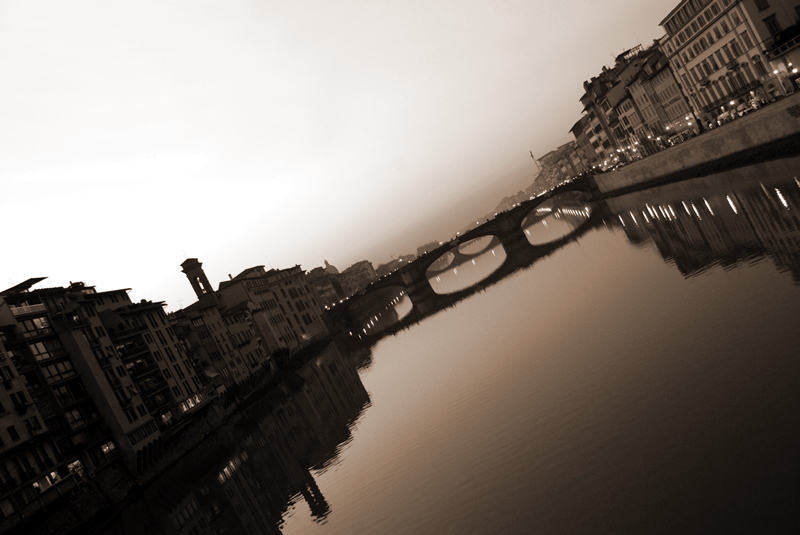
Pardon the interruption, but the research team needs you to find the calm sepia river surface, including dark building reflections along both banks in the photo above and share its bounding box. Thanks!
[100,159,800,535]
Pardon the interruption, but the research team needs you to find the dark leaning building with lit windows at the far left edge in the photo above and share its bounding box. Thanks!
[0,277,119,527]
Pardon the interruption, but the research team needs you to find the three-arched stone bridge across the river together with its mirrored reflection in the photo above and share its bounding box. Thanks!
[332,184,603,340]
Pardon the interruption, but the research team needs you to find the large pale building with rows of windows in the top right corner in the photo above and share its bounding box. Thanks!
[660,0,799,124]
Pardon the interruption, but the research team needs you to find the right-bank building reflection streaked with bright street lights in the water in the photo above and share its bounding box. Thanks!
[615,179,800,283]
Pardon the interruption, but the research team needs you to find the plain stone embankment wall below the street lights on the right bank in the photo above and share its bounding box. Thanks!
[593,92,800,195]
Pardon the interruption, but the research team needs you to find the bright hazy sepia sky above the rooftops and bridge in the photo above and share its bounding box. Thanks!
[0,0,678,309]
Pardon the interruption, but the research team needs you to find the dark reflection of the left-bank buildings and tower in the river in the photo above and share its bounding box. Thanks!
[101,342,369,535]
